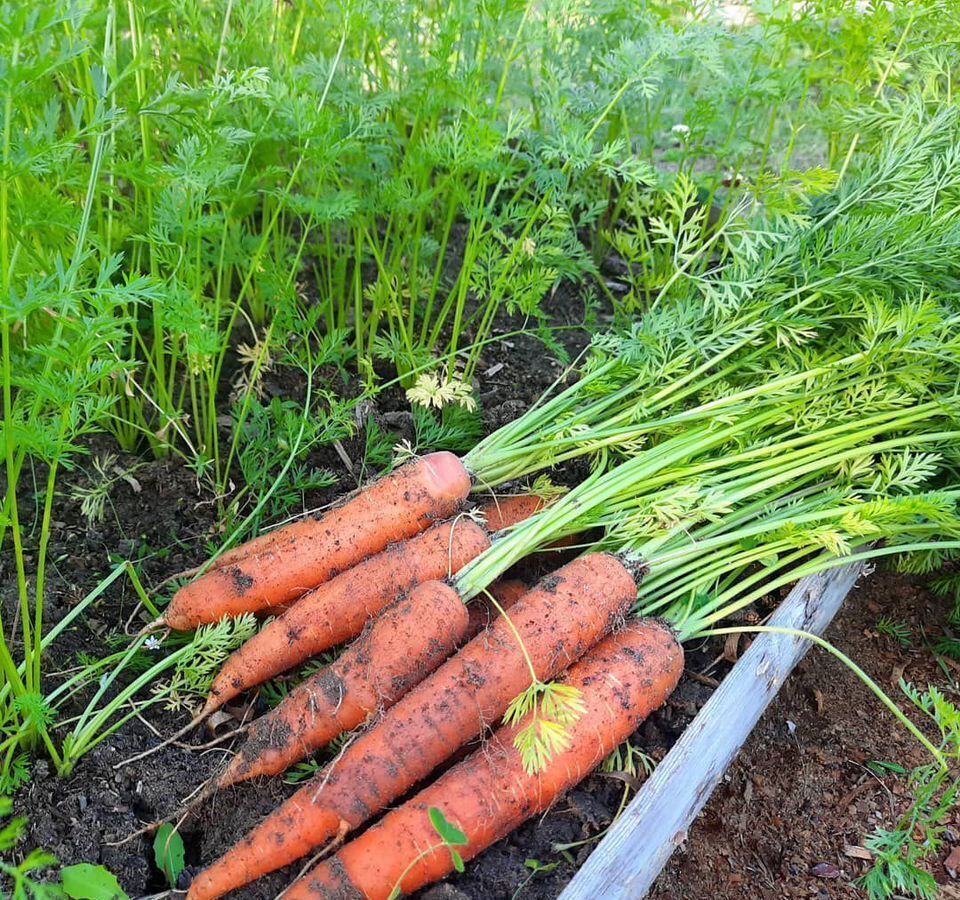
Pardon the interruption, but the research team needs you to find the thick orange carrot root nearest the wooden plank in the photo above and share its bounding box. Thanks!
[283,619,683,900]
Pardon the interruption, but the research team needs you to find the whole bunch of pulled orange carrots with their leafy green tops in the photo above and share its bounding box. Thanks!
[127,116,960,900]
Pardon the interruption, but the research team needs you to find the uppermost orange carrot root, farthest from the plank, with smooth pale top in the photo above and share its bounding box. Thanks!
[163,452,471,630]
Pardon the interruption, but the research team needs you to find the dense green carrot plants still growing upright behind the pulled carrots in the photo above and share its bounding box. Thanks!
[11,0,952,491]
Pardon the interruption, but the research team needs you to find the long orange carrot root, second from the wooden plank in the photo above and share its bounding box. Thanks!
[188,553,636,900]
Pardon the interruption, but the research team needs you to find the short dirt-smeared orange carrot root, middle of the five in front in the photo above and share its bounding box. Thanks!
[218,581,470,787]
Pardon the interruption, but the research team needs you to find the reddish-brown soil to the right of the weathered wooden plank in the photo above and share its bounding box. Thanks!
[651,573,960,900]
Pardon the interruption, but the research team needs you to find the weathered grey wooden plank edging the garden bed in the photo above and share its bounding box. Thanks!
[560,563,864,900]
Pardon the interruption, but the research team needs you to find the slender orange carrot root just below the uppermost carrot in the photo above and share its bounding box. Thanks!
[197,518,490,719]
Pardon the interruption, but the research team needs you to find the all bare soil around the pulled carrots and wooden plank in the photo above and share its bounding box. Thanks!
[11,304,960,900]
